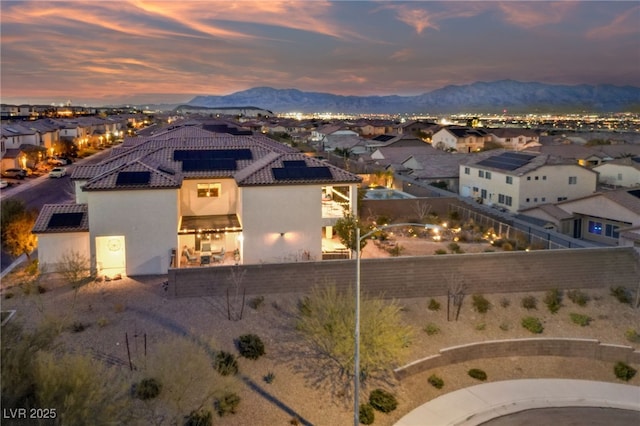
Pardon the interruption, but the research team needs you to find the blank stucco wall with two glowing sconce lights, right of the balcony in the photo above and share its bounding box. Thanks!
[240,185,322,263]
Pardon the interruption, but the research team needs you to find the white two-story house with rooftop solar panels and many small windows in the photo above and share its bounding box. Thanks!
[460,150,597,212]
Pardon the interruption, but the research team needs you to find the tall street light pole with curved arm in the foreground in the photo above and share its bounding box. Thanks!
[353,221,442,426]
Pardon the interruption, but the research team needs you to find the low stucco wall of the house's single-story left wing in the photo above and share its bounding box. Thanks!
[38,232,91,272]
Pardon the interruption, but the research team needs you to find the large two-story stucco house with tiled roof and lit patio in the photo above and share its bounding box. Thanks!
[33,126,361,276]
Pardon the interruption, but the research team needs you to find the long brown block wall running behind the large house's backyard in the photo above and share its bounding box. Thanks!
[167,247,640,298]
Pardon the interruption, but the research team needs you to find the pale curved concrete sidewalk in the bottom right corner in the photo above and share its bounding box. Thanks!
[395,379,640,426]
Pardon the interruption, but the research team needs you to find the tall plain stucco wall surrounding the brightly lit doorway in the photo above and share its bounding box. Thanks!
[88,189,178,275]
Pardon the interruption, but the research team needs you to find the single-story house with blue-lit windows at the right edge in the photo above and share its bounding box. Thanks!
[521,188,640,245]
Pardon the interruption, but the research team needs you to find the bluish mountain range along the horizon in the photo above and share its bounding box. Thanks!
[188,80,640,114]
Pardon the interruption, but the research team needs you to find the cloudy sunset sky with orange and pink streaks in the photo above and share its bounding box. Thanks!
[0,0,640,106]
